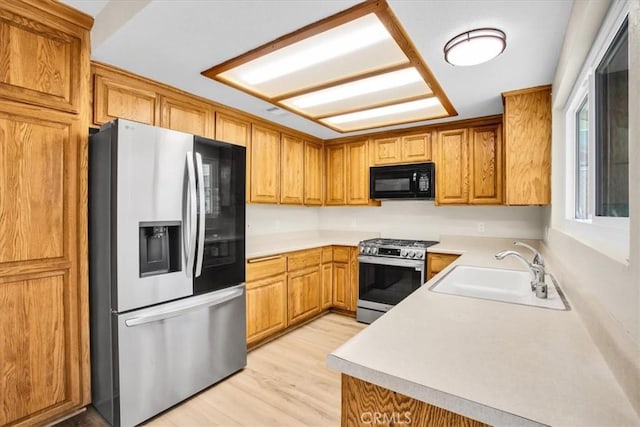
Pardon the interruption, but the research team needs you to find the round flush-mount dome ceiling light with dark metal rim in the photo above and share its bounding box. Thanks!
[444,28,507,66]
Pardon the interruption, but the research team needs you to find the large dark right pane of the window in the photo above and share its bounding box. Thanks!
[595,21,629,217]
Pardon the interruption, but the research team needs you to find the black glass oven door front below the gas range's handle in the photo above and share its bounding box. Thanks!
[358,262,422,305]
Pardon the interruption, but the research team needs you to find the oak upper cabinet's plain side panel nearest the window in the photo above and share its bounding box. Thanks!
[502,86,551,205]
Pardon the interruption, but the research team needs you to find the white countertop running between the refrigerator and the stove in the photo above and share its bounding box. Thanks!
[246,231,380,259]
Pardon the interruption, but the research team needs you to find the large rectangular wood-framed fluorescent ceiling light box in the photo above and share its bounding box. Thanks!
[202,0,458,132]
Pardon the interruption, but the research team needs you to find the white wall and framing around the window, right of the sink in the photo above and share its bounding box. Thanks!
[545,0,640,413]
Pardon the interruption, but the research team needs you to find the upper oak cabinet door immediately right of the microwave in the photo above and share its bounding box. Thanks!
[436,129,469,205]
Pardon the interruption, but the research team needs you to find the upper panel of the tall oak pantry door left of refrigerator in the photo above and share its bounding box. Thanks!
[0,112,69,264]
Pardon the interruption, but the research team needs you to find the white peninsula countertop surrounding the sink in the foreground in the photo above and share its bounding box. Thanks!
[327,237,640,426]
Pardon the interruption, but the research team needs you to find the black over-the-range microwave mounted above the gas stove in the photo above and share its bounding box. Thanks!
[369,162,436,200]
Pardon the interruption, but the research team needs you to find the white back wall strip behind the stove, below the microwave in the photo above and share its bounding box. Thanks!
[320,200,544,240]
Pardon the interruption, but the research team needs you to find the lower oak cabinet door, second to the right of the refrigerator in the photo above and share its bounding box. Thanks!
[287,266,321,325]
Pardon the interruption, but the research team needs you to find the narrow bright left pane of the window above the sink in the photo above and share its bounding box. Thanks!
[575,98,589,219]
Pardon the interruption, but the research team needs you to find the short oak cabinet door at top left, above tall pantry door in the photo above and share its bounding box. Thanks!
[0,0,91,113]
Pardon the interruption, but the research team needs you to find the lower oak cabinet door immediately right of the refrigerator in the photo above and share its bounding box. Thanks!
[247,274,287,345]
